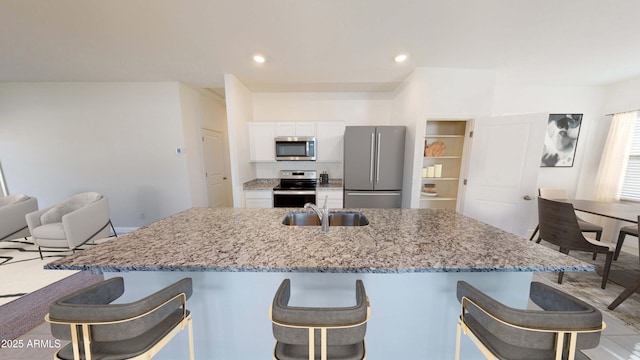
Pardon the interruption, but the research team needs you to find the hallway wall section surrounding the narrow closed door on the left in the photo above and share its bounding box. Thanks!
[179,83,231,207]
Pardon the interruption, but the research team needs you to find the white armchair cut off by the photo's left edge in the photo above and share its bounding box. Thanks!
[0,194,38,241]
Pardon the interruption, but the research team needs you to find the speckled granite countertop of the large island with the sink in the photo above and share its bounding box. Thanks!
[45,208,594,273]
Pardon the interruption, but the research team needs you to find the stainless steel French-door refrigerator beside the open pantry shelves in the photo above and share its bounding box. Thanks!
[344,126,406,208]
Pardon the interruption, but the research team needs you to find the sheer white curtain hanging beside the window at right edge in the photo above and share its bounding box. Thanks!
[596,111,638,201]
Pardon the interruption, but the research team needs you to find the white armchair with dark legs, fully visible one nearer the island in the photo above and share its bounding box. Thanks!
[26,192,117,259]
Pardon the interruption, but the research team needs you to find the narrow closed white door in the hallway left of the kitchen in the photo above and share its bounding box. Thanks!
[202,129,231,207]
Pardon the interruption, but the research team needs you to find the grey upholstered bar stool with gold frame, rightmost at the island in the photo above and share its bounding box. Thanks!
[456,281,605,360]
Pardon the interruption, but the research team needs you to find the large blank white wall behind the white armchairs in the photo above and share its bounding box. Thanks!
[0,82,190,228]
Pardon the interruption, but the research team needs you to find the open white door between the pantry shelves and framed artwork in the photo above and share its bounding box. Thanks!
[463,114,549,236]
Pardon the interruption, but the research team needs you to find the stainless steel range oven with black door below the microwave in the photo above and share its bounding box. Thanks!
[273,170,318,207]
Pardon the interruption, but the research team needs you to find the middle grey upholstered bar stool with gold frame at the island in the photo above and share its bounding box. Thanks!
[270,279,370,360]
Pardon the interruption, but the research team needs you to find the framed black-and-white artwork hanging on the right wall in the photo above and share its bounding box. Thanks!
[540,114,582,167]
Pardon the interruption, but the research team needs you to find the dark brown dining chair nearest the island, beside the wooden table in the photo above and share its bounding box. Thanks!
[538,197,615,289]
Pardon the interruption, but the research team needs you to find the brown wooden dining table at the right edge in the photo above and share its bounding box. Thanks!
[563,199,640,310]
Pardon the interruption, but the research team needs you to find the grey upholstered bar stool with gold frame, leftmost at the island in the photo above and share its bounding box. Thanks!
[45,277,194,360]
